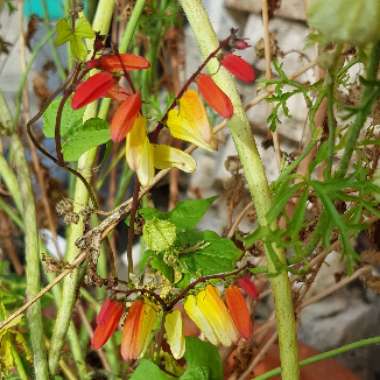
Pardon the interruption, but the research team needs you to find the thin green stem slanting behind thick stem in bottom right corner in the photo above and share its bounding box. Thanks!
[253,336,380,380]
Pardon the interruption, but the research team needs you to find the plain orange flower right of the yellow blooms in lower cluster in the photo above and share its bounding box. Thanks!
[226,285,253,339]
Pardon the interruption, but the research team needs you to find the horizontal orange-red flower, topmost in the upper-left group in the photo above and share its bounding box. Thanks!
[87,54,150,72]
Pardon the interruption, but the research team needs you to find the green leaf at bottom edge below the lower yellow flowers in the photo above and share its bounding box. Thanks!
[180,337,223,380]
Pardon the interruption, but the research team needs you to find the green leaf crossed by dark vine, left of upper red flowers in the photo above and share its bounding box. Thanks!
[42,96,84,138]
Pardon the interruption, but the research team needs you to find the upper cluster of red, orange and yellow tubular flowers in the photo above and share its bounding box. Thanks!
[71,45,255,186]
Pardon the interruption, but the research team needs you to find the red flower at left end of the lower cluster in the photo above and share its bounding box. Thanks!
[91,298,124,350]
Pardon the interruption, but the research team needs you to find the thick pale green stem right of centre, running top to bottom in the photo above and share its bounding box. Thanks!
[180,0,299,380]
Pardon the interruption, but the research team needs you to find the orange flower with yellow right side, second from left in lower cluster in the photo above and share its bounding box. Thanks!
[121,300,159,360]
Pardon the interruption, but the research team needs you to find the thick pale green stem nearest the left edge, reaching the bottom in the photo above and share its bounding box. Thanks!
[12,135,49,380]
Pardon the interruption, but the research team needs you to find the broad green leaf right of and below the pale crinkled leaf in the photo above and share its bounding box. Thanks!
[178,230,241,275]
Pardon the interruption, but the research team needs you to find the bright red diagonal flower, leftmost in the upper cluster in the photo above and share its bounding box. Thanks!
[71,73,114,110]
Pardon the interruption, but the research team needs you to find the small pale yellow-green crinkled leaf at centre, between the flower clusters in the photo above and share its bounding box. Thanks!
[143,218,176,252]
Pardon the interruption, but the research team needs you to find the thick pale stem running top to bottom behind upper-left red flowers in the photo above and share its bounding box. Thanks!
[49,0,115,374]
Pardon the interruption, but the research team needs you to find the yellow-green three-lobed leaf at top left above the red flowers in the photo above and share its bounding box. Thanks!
[54,15,95,61]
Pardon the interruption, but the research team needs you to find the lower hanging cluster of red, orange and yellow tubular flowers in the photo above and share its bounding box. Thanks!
[91,277,257,360]
